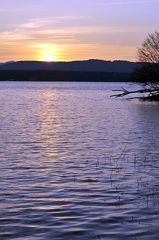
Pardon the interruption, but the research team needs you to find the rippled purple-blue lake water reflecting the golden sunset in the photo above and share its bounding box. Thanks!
[0,82,159,240]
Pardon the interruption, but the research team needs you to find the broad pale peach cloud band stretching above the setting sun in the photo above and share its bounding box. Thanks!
[1,21,139,46]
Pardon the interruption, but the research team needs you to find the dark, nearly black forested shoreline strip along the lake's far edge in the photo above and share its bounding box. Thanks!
[0,70,130,82]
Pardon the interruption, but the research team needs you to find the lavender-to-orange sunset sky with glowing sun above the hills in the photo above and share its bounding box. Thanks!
[0,0,159,62]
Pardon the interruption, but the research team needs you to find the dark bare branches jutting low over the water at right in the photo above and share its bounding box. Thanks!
[110,88,159,97]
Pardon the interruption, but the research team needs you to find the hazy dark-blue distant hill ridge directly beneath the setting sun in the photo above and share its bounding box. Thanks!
[0,60,137,73]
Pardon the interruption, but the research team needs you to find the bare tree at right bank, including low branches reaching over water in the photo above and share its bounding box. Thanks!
[114,31,159,101]
